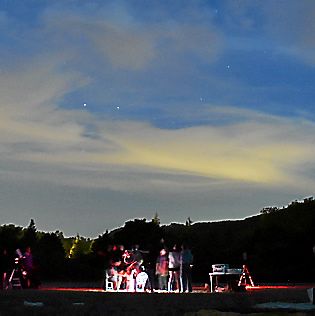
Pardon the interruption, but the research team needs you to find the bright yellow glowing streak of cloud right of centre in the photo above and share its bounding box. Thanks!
[97,121,310,184]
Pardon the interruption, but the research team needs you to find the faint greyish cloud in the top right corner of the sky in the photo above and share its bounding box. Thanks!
[225,0,315,65]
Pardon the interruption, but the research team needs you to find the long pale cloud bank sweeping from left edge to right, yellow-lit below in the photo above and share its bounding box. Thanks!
[0,52,315,189]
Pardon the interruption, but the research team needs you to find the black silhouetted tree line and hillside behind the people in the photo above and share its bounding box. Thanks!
[0,198,315,283]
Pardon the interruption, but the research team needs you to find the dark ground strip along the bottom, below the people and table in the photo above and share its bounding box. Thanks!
[0,287,315,316]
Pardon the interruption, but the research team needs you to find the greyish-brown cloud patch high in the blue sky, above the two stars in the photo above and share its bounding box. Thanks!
[37,4,223,71]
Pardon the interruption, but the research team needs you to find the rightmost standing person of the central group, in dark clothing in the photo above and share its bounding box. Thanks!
[180,244,193,293]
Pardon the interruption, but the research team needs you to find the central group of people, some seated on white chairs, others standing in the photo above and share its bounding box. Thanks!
[104,244,193,292]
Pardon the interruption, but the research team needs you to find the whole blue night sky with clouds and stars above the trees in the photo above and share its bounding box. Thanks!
[0,0,315,237]
